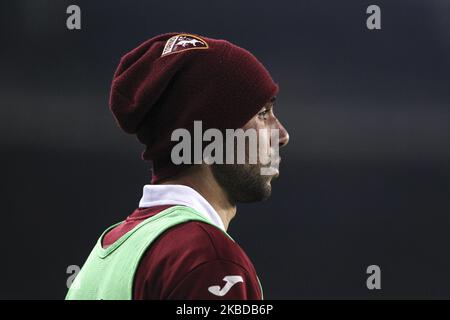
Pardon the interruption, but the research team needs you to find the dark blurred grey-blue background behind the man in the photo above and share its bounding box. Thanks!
[0,0,450,299]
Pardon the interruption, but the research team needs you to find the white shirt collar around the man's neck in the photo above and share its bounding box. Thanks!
[139,184,225,231]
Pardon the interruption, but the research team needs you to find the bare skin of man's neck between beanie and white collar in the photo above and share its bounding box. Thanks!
[161,165,236,230]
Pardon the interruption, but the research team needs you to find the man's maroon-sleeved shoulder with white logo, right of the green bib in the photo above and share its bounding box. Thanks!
[134,221,261,299]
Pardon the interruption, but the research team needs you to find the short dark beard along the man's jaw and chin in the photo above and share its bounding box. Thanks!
[211,164,273,203]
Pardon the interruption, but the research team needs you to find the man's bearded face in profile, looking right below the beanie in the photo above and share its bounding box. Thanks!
[211,99,289,202]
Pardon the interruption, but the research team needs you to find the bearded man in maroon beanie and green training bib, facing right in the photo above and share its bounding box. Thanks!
[67,33,289,299]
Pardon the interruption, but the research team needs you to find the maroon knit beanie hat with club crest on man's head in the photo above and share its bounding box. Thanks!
[109,33,278,183]
